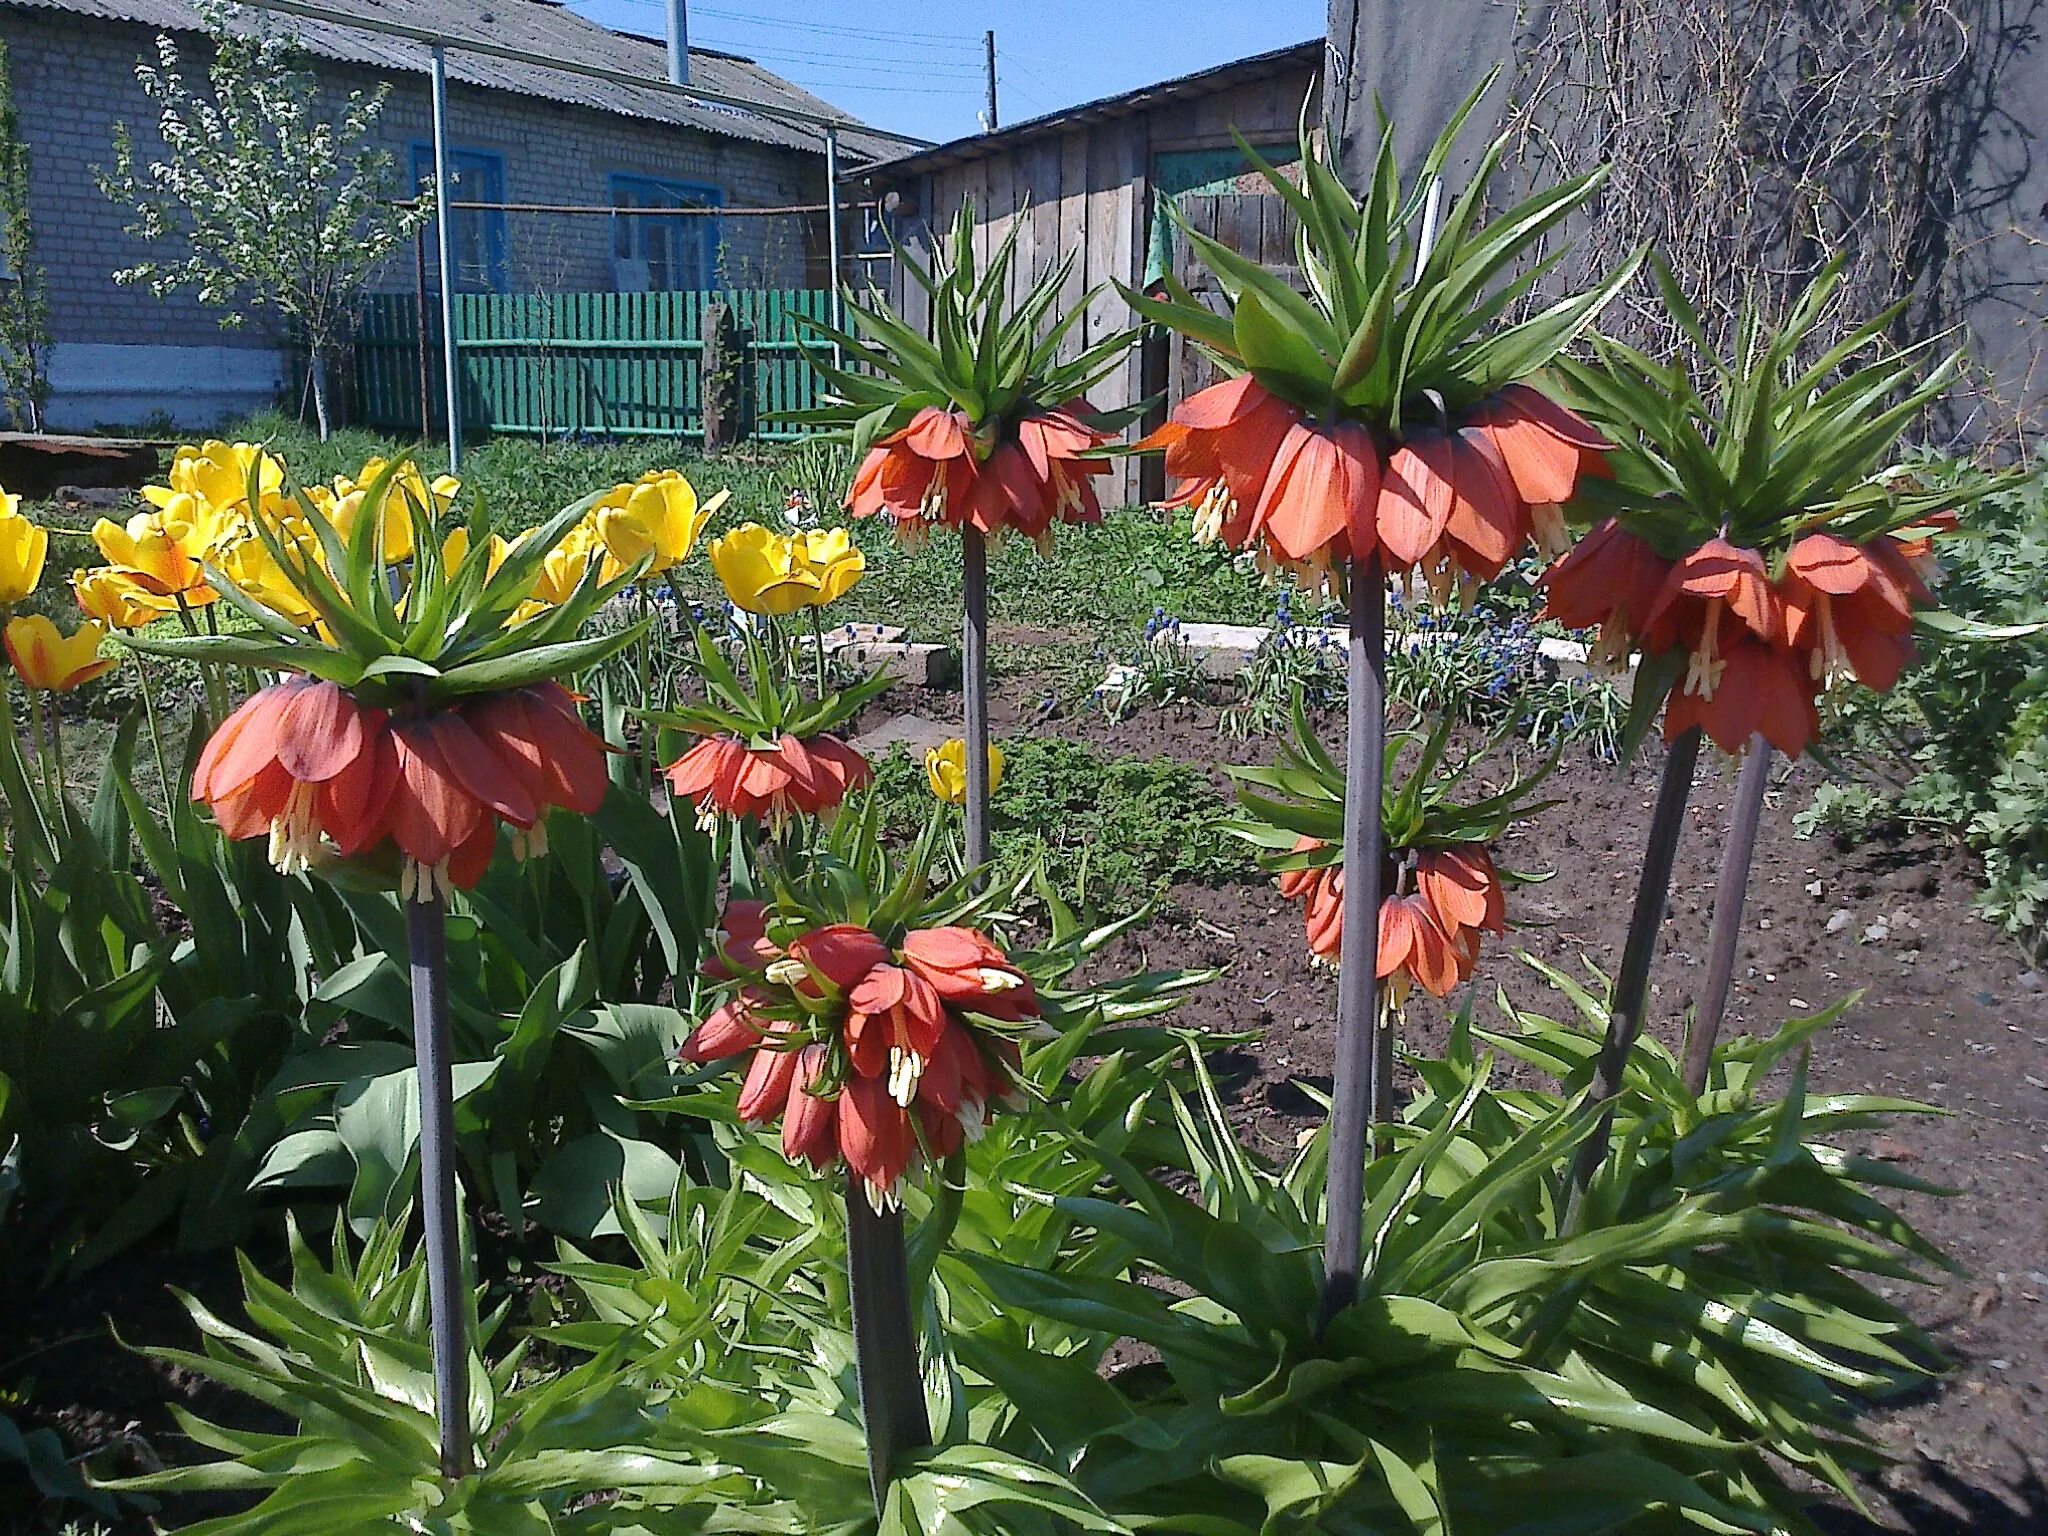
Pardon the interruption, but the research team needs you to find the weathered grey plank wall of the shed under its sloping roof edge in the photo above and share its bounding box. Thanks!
[876,70,1319,500]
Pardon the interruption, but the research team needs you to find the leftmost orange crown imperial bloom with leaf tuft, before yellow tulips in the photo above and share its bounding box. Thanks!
[125,461,637,901]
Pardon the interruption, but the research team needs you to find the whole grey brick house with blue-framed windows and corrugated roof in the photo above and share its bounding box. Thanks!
[0,0,907,430]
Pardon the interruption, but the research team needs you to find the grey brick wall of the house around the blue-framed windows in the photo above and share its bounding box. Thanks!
[0,6,823,428]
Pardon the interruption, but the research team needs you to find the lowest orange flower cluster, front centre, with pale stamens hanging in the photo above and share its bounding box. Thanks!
[680,903,1038,1210]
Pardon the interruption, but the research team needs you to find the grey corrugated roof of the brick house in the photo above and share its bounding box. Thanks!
[0,0,921,160]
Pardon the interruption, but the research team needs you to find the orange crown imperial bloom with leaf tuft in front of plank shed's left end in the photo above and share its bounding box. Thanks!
[805,203,1145,551]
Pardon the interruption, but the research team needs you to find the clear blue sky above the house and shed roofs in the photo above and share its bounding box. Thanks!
[569,0,1325,139]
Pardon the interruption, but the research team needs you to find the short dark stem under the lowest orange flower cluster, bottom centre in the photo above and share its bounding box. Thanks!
[846,1171,932,1513]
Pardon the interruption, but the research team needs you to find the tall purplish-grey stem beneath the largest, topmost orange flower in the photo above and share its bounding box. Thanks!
[1318,555,1393,1323]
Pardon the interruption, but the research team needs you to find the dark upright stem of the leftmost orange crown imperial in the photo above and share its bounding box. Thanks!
[406,893,469,1479]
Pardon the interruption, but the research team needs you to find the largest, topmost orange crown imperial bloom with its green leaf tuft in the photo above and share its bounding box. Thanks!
[1124,78,1634,590]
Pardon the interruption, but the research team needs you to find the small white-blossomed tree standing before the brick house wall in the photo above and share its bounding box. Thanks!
[100,2,430,436]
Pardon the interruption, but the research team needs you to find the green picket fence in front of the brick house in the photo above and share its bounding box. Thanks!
[354,289,831,440]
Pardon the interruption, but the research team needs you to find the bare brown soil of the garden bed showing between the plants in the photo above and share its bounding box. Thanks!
[12,651,2048,1536]
